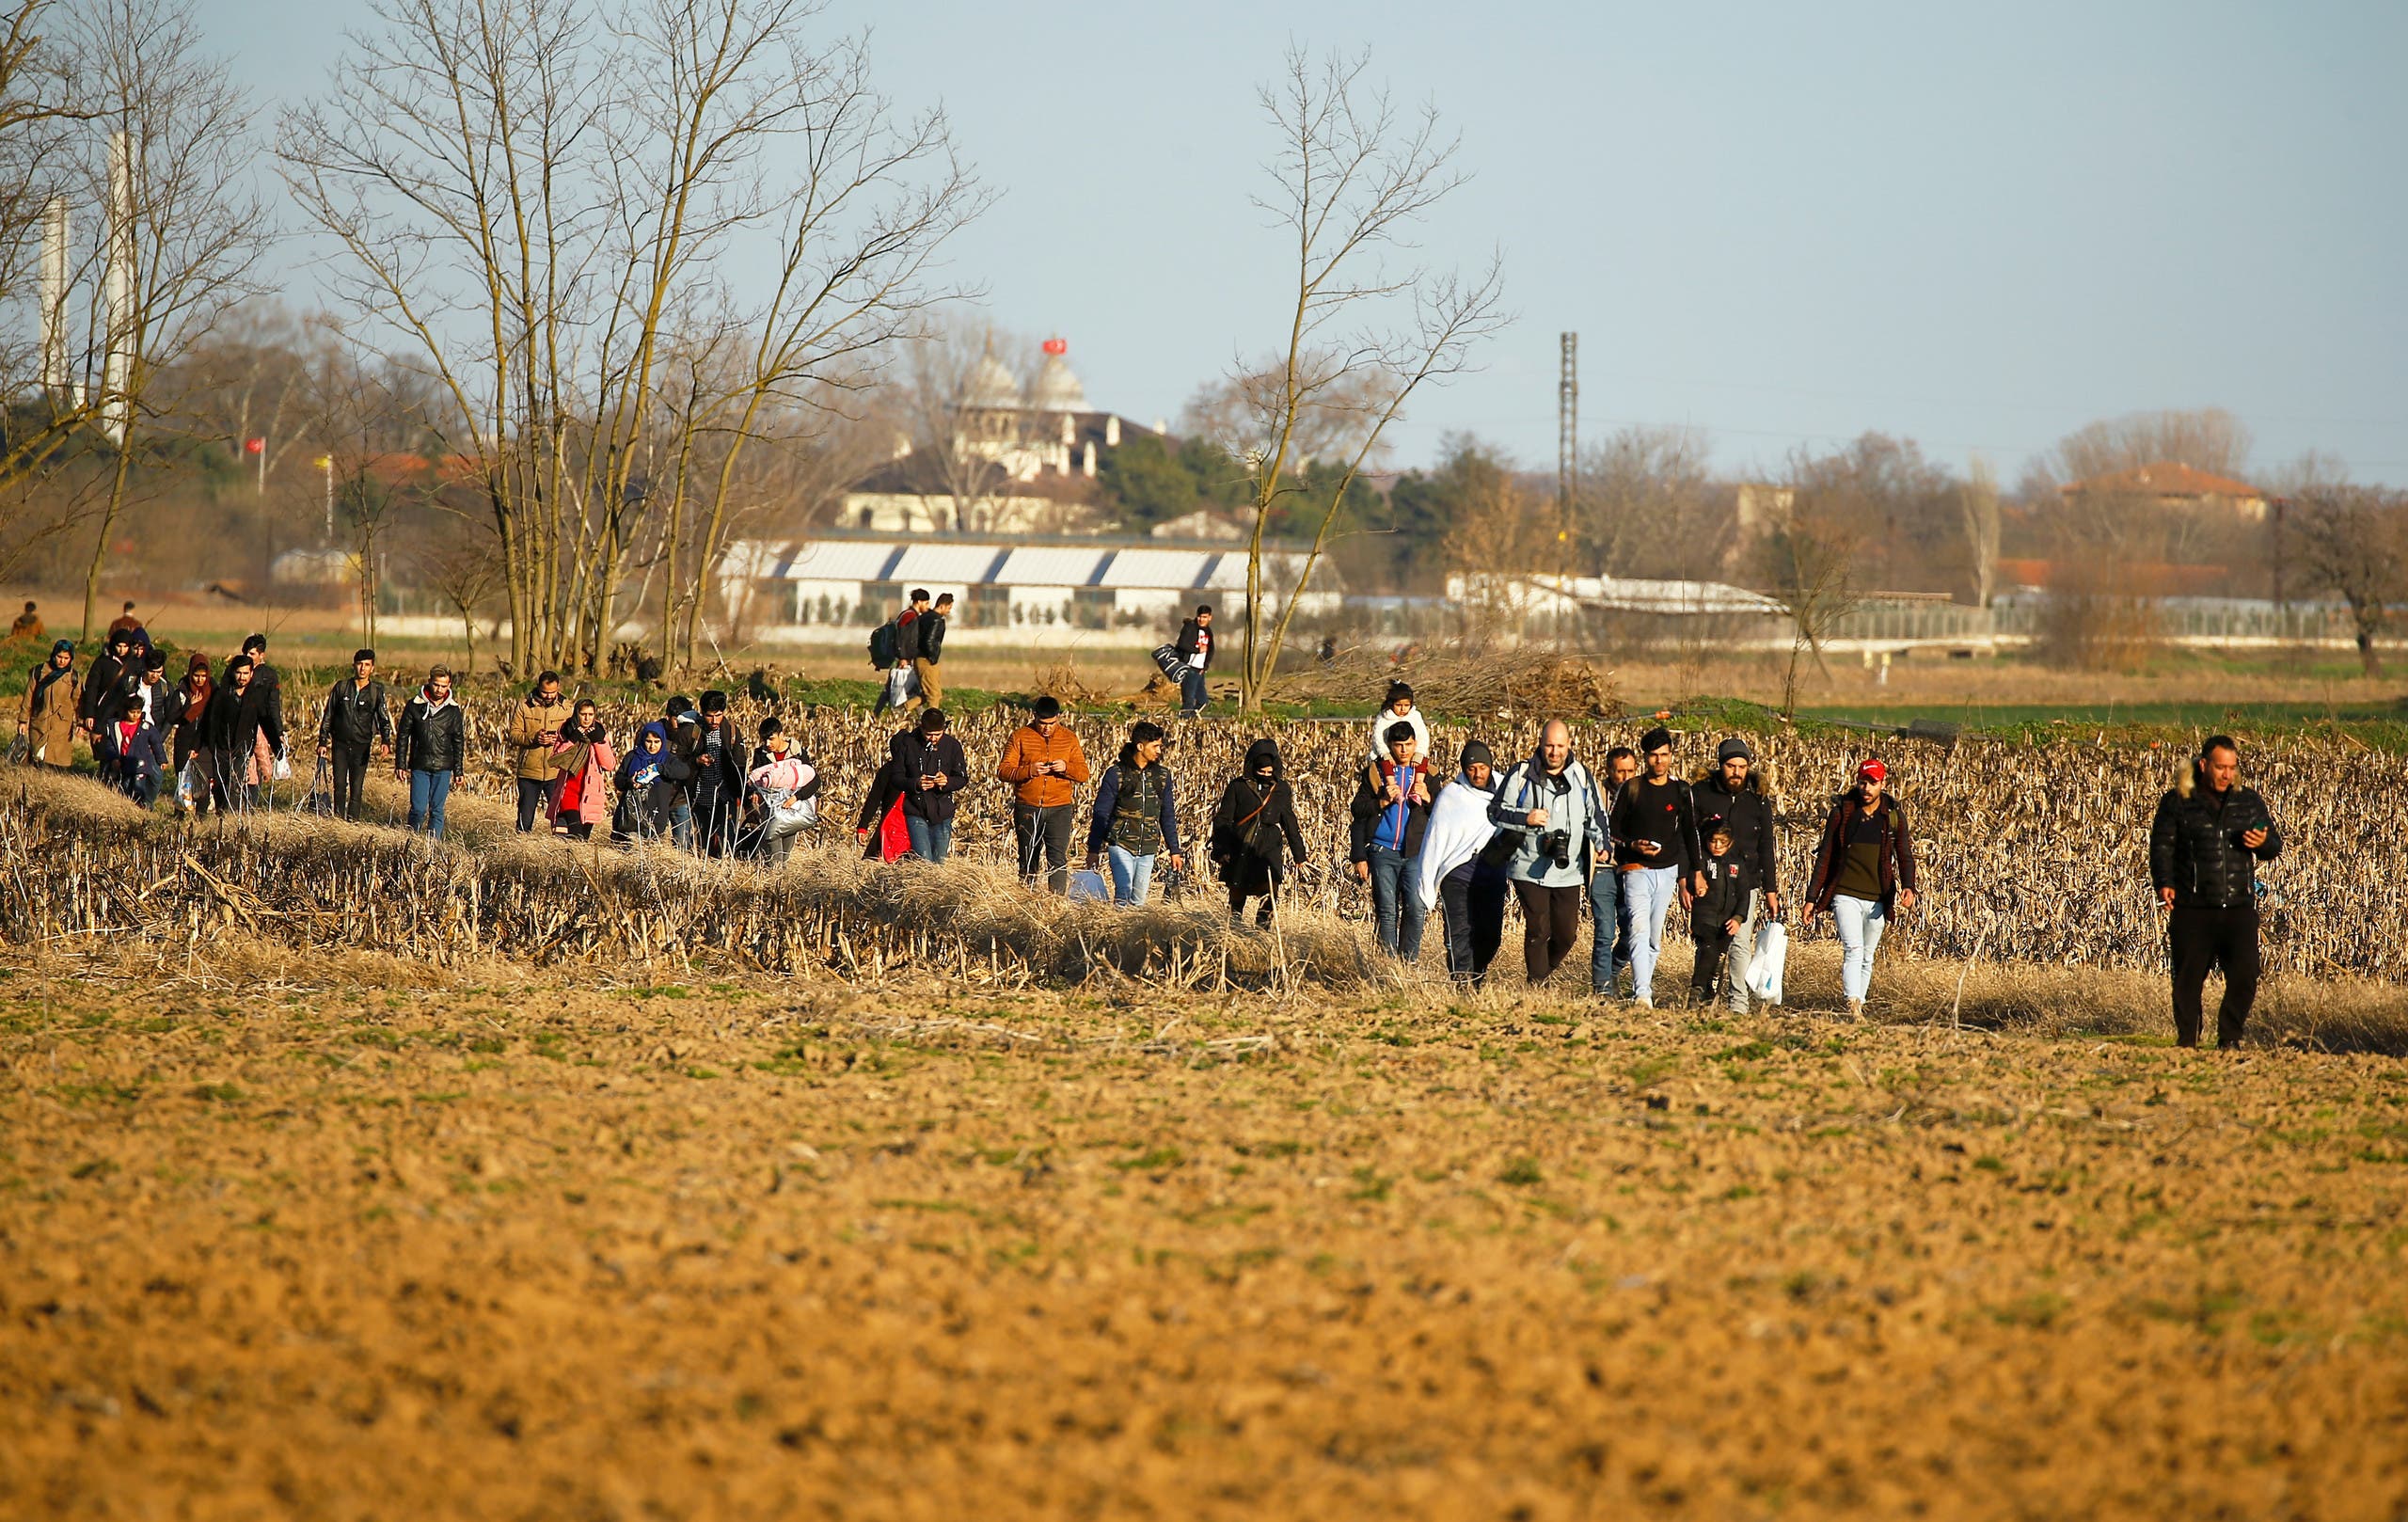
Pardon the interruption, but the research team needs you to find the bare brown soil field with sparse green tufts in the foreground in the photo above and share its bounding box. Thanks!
[0,953,2408,1517]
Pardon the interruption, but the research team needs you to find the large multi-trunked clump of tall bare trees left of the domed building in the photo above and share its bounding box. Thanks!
[279,0,980,667]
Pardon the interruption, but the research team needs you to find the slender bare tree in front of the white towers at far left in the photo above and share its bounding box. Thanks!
[68,0,275,638]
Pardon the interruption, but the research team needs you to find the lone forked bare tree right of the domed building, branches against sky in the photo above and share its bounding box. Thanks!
[1218,48,1510,710]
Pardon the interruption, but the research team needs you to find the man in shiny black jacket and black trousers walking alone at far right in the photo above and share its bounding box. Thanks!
[2148,735,2283,1050]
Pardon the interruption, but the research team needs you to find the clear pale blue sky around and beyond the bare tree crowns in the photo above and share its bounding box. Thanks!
[199,0,2408,482]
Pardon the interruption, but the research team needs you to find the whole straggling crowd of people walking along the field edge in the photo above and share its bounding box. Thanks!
[17,611,2283,1045]
